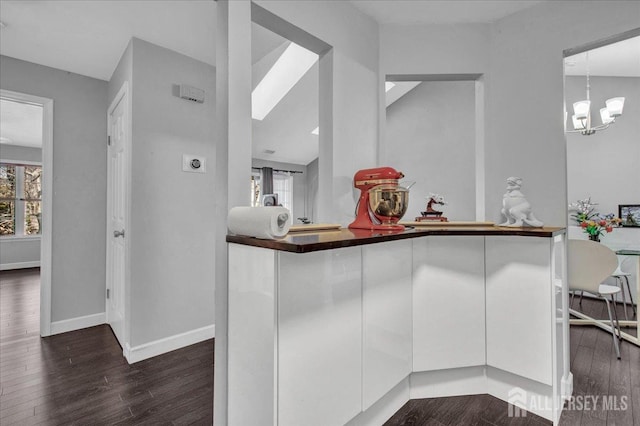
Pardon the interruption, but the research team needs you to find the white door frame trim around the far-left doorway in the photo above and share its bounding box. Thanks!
[0,89,53,337]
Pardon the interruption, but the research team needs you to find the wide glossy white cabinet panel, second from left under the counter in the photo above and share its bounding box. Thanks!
[277,247,362,426]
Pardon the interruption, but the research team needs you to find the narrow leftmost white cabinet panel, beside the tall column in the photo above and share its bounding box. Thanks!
[227,244,276,426]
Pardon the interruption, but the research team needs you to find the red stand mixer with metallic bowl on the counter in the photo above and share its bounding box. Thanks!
[349,167,409,231]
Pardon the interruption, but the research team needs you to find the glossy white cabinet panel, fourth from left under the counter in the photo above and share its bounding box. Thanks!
[412,236,485,371]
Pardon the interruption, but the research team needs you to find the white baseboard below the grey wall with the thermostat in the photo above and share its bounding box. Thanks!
[122,325,216,364]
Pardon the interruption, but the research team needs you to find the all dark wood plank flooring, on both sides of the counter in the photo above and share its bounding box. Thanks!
[0,269,640,426]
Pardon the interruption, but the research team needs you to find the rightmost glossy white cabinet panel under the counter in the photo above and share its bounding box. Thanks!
[486,236,554,385]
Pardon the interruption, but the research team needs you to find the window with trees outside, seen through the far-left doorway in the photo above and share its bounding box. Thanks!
[0,163,42,236]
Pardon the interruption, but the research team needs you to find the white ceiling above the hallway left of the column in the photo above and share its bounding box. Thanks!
[0,0,216,80]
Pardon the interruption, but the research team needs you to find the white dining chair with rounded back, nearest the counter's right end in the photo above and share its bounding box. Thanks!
[567,240,621,359]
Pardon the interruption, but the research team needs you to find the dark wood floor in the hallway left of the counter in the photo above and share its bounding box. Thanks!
[0,269,213,426]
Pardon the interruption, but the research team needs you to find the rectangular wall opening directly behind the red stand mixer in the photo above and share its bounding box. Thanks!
[379,74,485,222]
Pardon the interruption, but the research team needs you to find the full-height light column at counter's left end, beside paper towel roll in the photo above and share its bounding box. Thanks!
[214,0,251,426]
